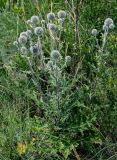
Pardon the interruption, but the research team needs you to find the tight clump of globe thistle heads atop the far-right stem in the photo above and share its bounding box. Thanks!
[103,18,115,30]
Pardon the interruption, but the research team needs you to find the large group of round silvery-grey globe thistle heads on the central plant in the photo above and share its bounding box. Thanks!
[14,10,67,63]
